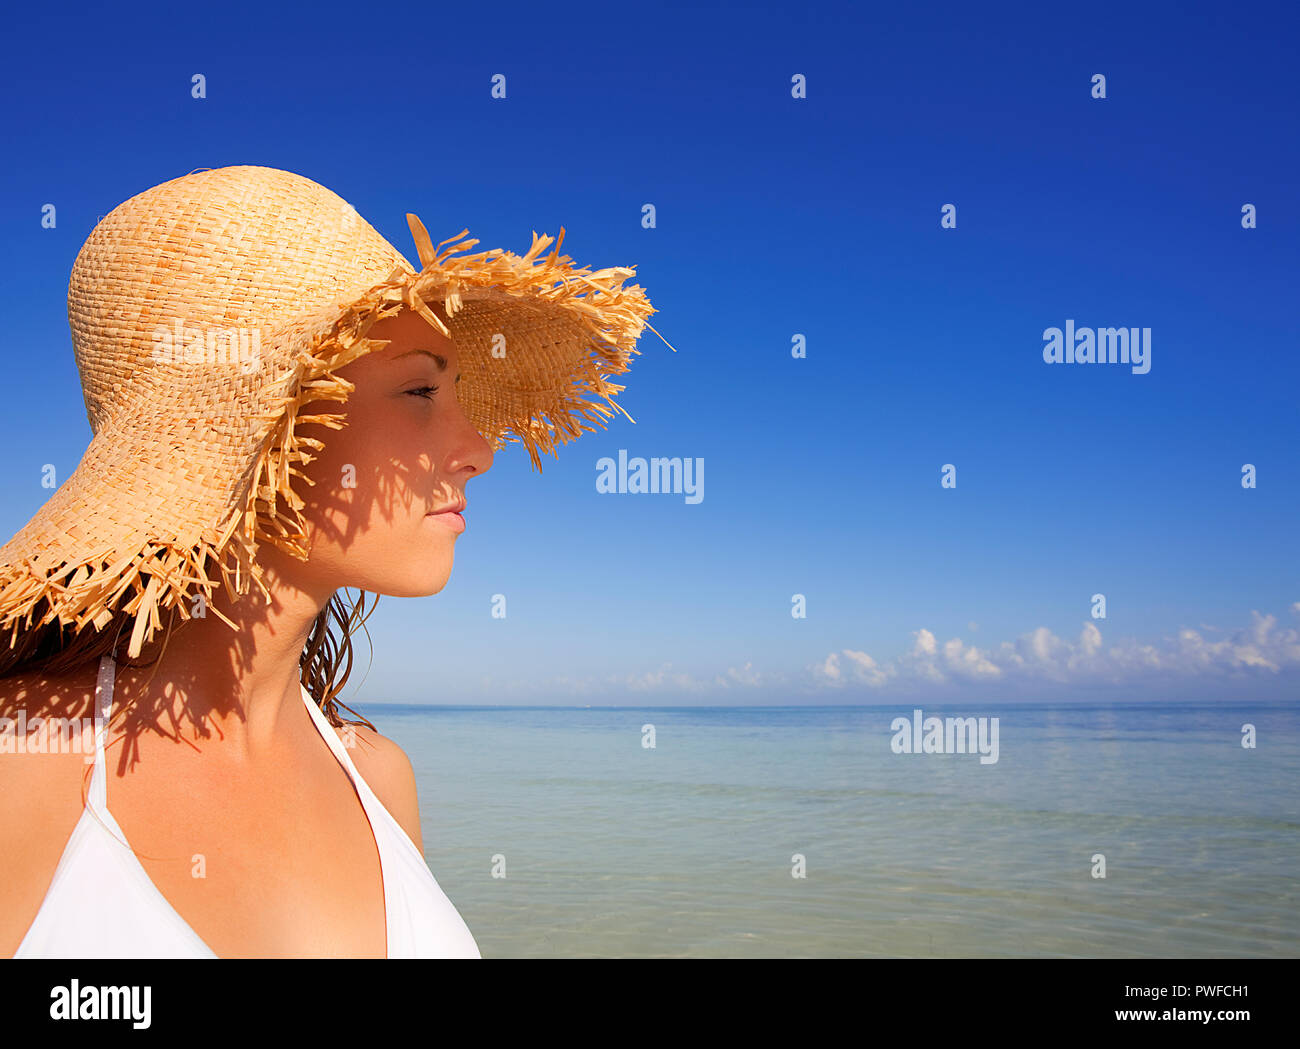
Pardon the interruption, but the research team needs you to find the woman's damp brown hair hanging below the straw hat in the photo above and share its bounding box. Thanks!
[0,590,378,731]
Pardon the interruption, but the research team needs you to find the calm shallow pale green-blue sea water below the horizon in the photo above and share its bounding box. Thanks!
[360,703,1300,958]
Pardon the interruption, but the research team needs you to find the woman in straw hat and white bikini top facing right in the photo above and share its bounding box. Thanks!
[0,168,654,957]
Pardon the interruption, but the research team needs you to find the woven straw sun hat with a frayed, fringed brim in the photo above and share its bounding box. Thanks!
[0,166,658,656]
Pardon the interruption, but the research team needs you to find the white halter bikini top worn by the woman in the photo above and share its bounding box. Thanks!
[14,655,481,958]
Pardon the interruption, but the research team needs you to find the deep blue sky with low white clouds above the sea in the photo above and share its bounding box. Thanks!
[0,4,1300,705]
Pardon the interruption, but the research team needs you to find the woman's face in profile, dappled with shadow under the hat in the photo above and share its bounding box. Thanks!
[295,309,493,597]
